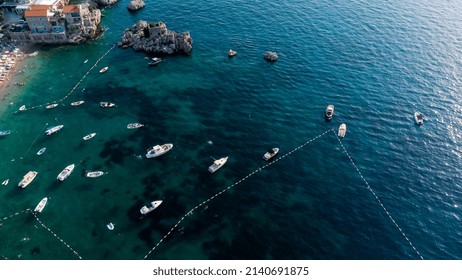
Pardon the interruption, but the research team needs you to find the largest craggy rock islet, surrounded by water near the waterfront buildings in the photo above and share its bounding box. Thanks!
[118,20,192,55]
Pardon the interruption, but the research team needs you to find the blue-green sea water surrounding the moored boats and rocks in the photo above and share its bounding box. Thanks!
[0,1,462,259]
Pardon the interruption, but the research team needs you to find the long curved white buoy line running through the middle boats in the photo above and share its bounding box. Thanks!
[143,129,332,259]
